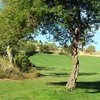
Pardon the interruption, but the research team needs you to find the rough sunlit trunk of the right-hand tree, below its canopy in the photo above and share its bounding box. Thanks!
[66,29,79,90]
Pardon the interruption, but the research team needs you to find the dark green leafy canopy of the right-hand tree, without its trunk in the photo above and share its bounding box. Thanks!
[38,0,100,42]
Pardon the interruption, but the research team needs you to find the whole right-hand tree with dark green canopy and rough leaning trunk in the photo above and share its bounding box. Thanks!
[36,0,100,90]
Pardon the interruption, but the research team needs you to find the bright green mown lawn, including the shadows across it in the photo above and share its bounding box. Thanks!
[0,54,100,100]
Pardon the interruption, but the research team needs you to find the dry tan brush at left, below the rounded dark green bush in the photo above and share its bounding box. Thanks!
[0,57,39,79]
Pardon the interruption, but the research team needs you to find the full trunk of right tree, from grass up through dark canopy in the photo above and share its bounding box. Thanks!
[66,0,82,90]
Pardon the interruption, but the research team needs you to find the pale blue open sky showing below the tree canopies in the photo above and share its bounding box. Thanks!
[36,29,100,51]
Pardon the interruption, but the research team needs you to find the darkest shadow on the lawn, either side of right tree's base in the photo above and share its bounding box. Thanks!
[47,81,100,93]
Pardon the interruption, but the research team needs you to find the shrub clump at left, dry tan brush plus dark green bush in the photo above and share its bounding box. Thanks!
[0,55,40,79]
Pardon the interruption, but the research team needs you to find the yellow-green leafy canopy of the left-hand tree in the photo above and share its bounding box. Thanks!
[0,0,38,62]
